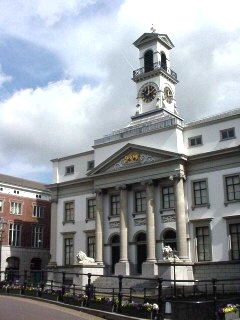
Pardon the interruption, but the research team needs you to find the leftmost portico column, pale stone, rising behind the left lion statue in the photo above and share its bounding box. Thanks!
[95,191,103,264]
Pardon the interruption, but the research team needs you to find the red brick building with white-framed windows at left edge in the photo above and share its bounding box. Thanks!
[0,174,51,280]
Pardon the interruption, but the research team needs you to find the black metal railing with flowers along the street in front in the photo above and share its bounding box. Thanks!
[0,270,240,320]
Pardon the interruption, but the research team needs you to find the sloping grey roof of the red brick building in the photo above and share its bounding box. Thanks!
[0,173,48,191]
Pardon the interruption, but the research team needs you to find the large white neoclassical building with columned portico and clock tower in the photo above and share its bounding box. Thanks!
[49,33,240,279]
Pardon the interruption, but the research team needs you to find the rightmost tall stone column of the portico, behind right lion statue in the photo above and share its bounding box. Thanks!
[174,174,188,260]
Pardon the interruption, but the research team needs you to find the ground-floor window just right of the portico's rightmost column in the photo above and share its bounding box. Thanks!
[196,227,211,261]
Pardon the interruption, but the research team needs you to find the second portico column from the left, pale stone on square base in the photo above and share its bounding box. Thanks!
[115,186,130,275]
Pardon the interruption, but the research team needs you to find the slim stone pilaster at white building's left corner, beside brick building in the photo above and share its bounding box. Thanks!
[48,199,58,268]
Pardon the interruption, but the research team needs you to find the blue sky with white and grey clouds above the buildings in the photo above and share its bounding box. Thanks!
[0,0,240,183]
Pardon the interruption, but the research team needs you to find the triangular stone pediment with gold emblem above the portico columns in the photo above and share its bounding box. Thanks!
[89,144,184,175]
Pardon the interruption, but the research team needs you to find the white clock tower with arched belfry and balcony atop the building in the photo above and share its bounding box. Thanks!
[132,29,178,115]
